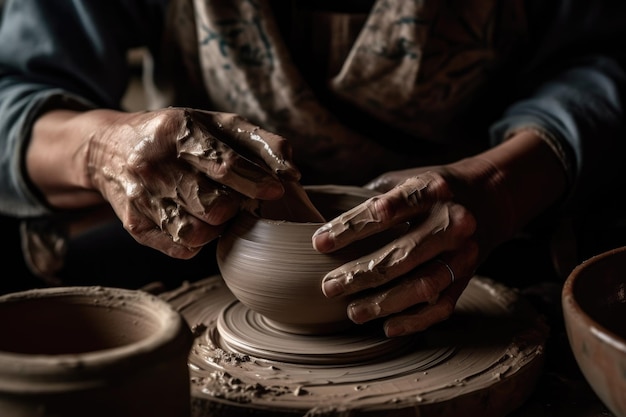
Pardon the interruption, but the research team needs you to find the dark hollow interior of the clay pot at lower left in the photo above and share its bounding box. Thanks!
[0,287,164,355]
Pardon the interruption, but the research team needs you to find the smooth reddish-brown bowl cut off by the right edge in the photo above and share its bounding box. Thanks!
[562,247,626,417]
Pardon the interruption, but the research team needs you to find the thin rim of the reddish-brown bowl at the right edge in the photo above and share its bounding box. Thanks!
[562,246,626,353]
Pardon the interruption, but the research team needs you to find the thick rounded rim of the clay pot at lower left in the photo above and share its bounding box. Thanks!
[0,286,192,392]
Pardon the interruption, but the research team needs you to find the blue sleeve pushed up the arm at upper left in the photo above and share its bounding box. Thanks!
[0,0,167,217]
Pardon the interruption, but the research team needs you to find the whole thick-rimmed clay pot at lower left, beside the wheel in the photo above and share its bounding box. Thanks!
[0,287,193,417]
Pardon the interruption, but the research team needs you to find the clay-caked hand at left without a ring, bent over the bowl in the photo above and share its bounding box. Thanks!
[87,108,300,258]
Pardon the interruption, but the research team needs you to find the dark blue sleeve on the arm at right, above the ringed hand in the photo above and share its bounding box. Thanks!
[491,1,626,210]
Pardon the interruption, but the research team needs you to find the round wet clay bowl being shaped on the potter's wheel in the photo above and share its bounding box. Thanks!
[217,185,398,334]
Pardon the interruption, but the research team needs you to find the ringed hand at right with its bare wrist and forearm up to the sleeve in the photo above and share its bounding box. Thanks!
[313,132,565,336]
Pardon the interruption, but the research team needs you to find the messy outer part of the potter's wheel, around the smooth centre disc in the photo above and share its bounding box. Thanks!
[162,276,547,416]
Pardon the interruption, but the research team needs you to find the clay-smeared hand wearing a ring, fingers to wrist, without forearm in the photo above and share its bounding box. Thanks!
[313,160,509,337]
